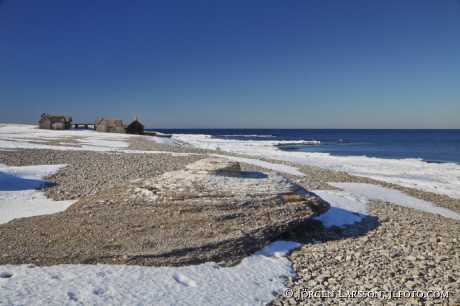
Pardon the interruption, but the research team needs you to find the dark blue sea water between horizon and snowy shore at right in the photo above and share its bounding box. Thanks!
[146,129,460,164]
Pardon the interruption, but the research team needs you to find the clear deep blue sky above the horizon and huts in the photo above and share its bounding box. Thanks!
[0,0,460,128]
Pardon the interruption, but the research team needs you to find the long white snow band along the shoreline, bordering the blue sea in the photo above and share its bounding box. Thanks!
[173,134,460,199]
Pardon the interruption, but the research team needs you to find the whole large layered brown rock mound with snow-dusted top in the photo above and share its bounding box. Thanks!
[0,158,330,265]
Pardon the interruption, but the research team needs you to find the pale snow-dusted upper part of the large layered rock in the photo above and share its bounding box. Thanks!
[140,158,329,201]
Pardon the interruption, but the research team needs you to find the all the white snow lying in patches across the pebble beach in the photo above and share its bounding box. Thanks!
[0,125,460,305]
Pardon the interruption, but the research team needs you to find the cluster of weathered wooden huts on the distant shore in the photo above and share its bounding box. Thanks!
[38,113,144,135]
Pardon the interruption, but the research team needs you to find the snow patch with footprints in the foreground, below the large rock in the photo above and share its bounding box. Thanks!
[0,242,300,305]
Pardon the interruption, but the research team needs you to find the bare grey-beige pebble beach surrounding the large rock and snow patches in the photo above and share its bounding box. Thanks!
[0,137,460,305]
